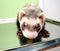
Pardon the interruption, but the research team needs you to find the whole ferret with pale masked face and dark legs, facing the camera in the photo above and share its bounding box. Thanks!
[16,4,49,45]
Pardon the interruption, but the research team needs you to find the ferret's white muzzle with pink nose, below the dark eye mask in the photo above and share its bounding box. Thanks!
[22,29,38,39]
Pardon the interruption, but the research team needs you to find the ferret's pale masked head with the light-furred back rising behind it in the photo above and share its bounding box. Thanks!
[18,4,45,39]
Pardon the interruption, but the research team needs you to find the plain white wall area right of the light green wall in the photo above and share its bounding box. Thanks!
[39,0,60,22]
